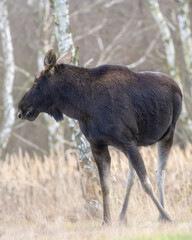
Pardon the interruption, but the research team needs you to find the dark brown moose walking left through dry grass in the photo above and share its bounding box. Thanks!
[18,49,182,223]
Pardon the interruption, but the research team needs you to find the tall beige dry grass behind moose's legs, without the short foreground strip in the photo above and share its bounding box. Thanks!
[0,145,192,239]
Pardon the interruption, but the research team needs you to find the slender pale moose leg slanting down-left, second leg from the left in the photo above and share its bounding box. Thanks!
[119,162,135,223]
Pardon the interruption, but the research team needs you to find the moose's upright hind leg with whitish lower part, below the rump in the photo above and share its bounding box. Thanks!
[156,127,174,220]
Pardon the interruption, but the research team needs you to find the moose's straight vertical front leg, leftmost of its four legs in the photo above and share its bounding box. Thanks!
[91,144,111,224]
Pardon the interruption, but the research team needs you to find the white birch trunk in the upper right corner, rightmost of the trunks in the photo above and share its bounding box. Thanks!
[176,0,192,94]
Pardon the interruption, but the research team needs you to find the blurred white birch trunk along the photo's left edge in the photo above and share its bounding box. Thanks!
[0,0,15,156]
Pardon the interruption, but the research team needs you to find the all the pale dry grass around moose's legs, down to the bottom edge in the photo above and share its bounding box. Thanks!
[0,145,192,240]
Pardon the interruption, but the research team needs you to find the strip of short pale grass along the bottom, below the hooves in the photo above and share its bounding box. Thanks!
[1,221,192,240]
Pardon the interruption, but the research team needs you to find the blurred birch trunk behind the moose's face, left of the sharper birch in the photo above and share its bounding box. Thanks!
[28,0,64,154]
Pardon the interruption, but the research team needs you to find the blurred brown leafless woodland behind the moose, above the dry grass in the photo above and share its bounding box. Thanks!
[0,0,192,156]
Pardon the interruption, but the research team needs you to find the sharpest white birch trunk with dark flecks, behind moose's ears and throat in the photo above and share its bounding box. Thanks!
[53,0,91,166]
